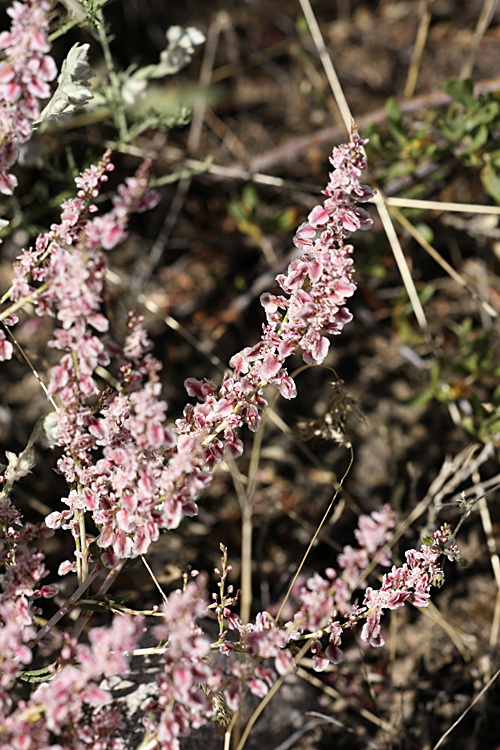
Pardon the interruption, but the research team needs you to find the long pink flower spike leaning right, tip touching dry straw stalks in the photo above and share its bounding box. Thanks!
[170,131,373,512]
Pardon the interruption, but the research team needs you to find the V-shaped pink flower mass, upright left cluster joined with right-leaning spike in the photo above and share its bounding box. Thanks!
[0,132,372,572]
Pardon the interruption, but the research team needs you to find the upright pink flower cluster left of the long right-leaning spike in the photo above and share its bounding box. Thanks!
[3,153,162,570]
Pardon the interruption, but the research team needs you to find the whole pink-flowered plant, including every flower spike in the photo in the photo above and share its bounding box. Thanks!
[0,0,459,750]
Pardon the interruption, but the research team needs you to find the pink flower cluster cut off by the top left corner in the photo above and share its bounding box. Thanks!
[0,0,57,195]
